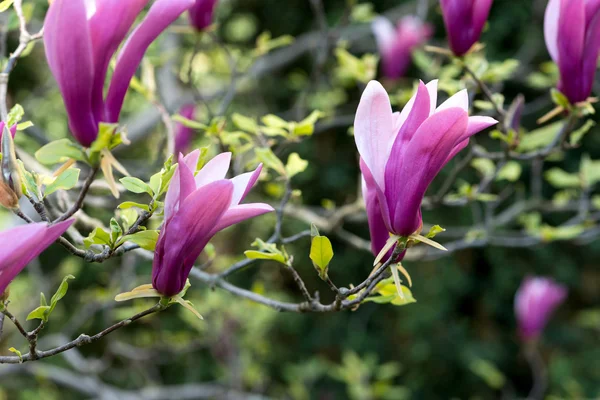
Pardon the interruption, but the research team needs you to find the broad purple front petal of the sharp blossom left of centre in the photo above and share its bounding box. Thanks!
[152,179,233,296]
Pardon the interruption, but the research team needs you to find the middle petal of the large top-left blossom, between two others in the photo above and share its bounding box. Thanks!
[89,0,149,121]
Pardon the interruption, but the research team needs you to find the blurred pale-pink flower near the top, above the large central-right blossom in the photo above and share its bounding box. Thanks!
[372,16,433,79]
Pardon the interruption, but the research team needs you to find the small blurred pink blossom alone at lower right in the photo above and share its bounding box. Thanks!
[515,277,567,340]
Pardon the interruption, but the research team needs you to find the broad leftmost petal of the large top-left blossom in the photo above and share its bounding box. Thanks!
[44,0,98,146]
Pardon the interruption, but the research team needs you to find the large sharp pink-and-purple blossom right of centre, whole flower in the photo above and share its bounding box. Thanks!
[354,80,497,255]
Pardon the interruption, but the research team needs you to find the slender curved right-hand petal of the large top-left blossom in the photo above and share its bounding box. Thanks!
[106,0,194,122]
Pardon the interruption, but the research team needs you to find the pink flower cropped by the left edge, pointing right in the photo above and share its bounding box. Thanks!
[0,220,73,295]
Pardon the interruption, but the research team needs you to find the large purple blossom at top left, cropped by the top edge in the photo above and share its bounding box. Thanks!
[44,0,194,146]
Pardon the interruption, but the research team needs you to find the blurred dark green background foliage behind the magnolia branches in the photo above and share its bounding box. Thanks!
[0,0,600,400]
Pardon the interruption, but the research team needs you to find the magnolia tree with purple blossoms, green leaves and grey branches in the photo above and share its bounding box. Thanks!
[0,0,600,398]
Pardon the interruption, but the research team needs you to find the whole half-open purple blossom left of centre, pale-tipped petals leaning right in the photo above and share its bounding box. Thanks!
[152,150,273,296]
